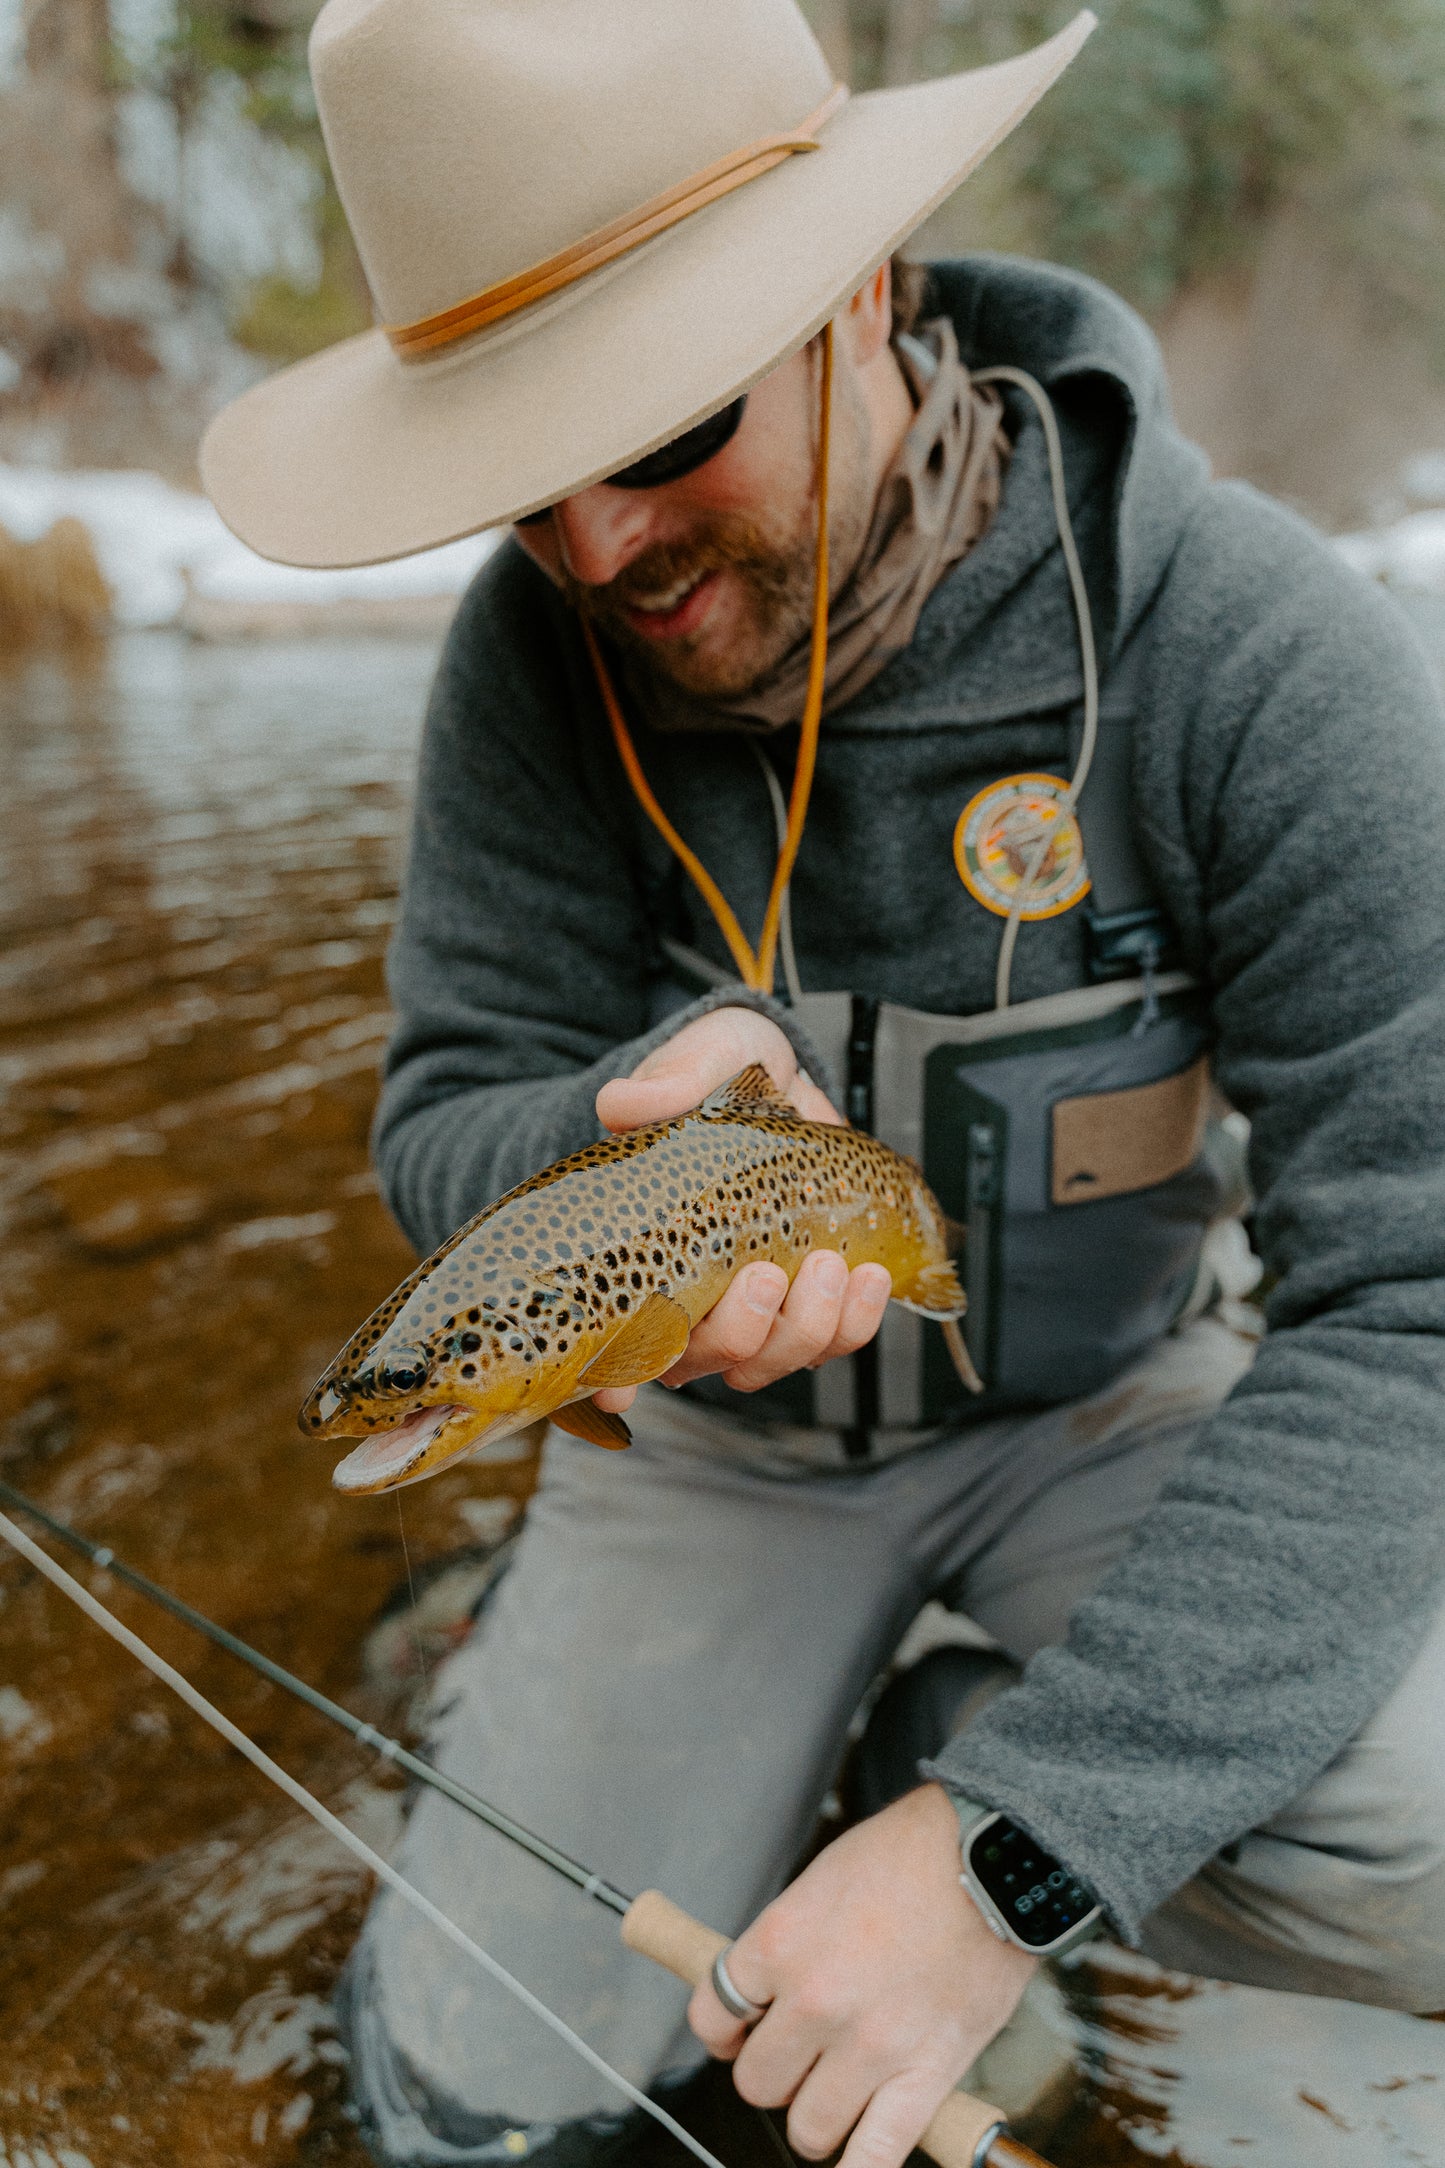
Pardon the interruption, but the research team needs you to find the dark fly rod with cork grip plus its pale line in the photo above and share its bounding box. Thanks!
[0,1483,1049,2168]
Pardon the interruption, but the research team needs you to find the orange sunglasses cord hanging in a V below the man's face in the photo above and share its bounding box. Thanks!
[581,323,832,993]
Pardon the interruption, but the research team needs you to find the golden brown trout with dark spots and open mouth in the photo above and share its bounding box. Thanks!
[301,1064,966,1494]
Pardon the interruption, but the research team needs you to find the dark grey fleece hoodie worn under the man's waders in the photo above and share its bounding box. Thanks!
[377,258,1445,1936]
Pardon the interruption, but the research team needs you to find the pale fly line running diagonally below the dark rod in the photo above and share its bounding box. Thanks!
[0,1513,721,2168]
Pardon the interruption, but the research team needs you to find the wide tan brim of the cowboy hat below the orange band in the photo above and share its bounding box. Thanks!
[201,11,1094,568]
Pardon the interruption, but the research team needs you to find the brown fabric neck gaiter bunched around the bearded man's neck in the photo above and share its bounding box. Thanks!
[626,317,1010,733]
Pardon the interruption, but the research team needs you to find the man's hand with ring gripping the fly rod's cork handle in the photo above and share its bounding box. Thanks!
[687,1784,1038,2168]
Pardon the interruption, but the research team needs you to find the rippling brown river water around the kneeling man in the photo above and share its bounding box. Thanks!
[0,633,1445,2168]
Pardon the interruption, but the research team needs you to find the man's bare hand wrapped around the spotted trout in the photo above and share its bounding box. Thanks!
[596,1008,893,1414]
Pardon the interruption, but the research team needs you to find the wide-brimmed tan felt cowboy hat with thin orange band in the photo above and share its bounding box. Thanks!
[201,0,1094,566]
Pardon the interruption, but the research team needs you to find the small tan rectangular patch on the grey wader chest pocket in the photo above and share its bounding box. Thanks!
[1051,1056,1209,1205]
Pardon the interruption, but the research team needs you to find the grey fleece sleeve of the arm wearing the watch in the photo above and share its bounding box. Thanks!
[932,488,1445,1938]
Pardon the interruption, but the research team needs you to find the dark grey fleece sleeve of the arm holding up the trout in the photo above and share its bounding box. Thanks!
[373,544,821,1253]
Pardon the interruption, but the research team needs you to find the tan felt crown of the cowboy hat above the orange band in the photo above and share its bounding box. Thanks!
[310,0,832,325]
